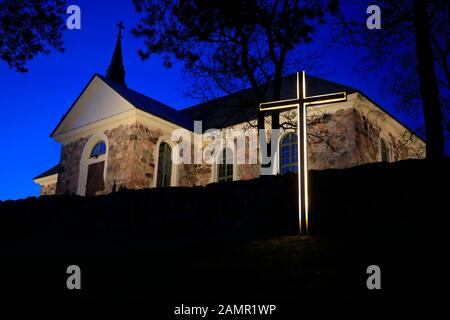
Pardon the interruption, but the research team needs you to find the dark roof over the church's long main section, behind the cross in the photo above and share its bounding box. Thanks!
[181,73,358,130]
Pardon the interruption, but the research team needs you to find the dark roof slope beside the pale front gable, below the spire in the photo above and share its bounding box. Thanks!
[97,74,194,130]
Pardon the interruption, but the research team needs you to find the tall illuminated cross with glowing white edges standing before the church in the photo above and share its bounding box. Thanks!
[259,71,347,234]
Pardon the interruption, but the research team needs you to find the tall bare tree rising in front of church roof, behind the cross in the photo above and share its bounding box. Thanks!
[133,0,338,129]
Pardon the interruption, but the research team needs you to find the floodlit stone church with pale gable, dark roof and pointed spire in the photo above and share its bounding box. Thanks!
[34,30,425,196]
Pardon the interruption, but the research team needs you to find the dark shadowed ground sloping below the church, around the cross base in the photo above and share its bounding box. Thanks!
[0,160,450,319]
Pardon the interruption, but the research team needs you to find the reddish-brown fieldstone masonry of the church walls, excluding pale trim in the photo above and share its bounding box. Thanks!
[48,108,422,195]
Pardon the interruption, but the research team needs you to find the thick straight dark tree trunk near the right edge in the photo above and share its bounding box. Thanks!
[413,0,445,160]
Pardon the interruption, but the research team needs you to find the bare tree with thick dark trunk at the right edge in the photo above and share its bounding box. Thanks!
[339,0,450,159]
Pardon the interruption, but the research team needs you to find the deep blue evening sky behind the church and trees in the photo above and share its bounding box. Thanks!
[0,0,426,200]
